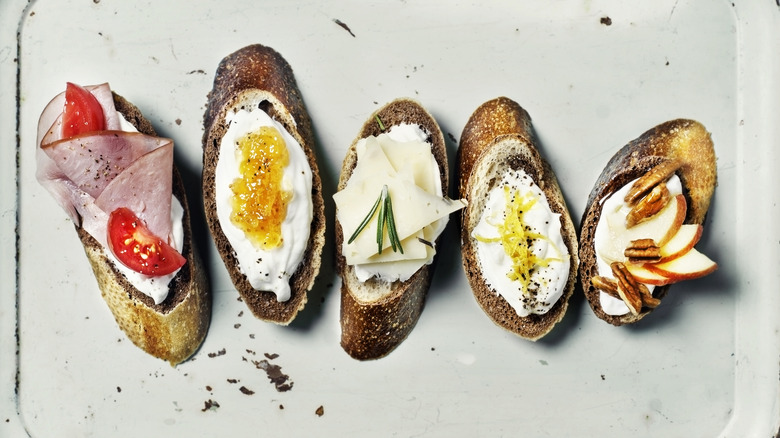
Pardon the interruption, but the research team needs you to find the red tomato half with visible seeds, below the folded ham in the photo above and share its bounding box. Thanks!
[108,207,187,275]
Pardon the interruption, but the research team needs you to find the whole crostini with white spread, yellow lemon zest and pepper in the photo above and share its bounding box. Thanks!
[457,97,578,341]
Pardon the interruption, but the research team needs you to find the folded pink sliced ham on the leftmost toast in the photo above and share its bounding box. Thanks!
[36,84,173,253]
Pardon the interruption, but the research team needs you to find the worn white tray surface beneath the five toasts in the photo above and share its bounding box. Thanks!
[0,0,780,437]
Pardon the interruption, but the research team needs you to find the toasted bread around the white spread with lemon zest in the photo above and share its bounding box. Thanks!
[458,97,578,341]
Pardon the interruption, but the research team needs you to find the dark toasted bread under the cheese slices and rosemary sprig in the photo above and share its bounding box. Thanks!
[335,98,449,360]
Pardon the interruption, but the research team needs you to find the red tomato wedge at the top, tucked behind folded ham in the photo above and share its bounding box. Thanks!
[62,82,106,138]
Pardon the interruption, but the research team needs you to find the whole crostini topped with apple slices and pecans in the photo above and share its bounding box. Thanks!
[580,119,717,326]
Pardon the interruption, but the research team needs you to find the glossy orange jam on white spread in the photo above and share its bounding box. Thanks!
[230,126,292,250]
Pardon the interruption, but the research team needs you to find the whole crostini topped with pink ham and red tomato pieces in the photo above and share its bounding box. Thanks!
[36,83,211,365]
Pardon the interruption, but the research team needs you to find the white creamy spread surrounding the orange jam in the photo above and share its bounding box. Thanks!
[215,109,314,302]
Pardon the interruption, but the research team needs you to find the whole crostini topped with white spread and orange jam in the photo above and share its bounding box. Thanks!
[203,44,325,325]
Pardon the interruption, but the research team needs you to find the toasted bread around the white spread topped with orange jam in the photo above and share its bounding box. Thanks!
[203,44,325,325]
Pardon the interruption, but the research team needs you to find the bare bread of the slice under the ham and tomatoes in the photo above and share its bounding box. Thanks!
[76,93,211,365]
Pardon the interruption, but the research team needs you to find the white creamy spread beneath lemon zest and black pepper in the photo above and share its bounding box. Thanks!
[471,169,570,317]
